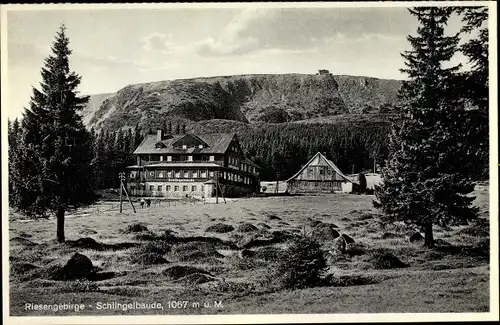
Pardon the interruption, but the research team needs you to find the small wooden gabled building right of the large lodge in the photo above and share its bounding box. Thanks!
[287,152,355,193]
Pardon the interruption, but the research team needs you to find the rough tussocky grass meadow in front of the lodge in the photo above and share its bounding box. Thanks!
[9,185,489,316]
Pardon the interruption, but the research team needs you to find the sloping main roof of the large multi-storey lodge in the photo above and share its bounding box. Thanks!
[134,133,235,155]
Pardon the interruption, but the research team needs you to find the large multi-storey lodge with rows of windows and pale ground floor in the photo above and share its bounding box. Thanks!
[127,130,260,198]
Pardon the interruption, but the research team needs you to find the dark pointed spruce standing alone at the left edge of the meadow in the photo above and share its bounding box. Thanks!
[13,25,94,242]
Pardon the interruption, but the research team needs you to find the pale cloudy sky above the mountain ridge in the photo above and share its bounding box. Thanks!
[2,4,472,118]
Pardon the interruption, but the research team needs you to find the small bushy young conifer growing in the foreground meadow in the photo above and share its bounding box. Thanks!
[273,238,327,289]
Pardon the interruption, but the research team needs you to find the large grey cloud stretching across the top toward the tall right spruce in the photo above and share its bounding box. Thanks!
[196,8,413,56]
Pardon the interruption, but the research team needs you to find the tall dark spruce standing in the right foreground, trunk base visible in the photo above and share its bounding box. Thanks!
[374,7,477,247]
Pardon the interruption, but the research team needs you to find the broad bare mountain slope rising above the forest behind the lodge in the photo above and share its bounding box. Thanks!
[83,74,401,130]
